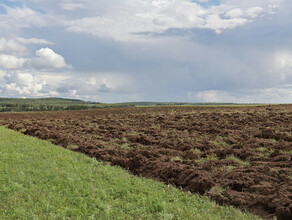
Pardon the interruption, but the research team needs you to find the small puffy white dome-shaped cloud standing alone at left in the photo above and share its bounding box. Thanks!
[31,47,67,69]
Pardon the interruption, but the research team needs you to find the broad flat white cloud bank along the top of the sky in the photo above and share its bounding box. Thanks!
[64,0,274,41]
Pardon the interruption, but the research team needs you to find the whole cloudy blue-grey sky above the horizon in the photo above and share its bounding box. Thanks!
[0,0,292,103]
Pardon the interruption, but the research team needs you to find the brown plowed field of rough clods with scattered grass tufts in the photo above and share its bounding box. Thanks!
[0,105,292,219]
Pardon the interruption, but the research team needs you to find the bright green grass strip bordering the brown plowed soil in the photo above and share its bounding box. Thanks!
[0,127,258,219]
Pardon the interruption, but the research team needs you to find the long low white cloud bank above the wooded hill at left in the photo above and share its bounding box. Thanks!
[0,70,137,101]
